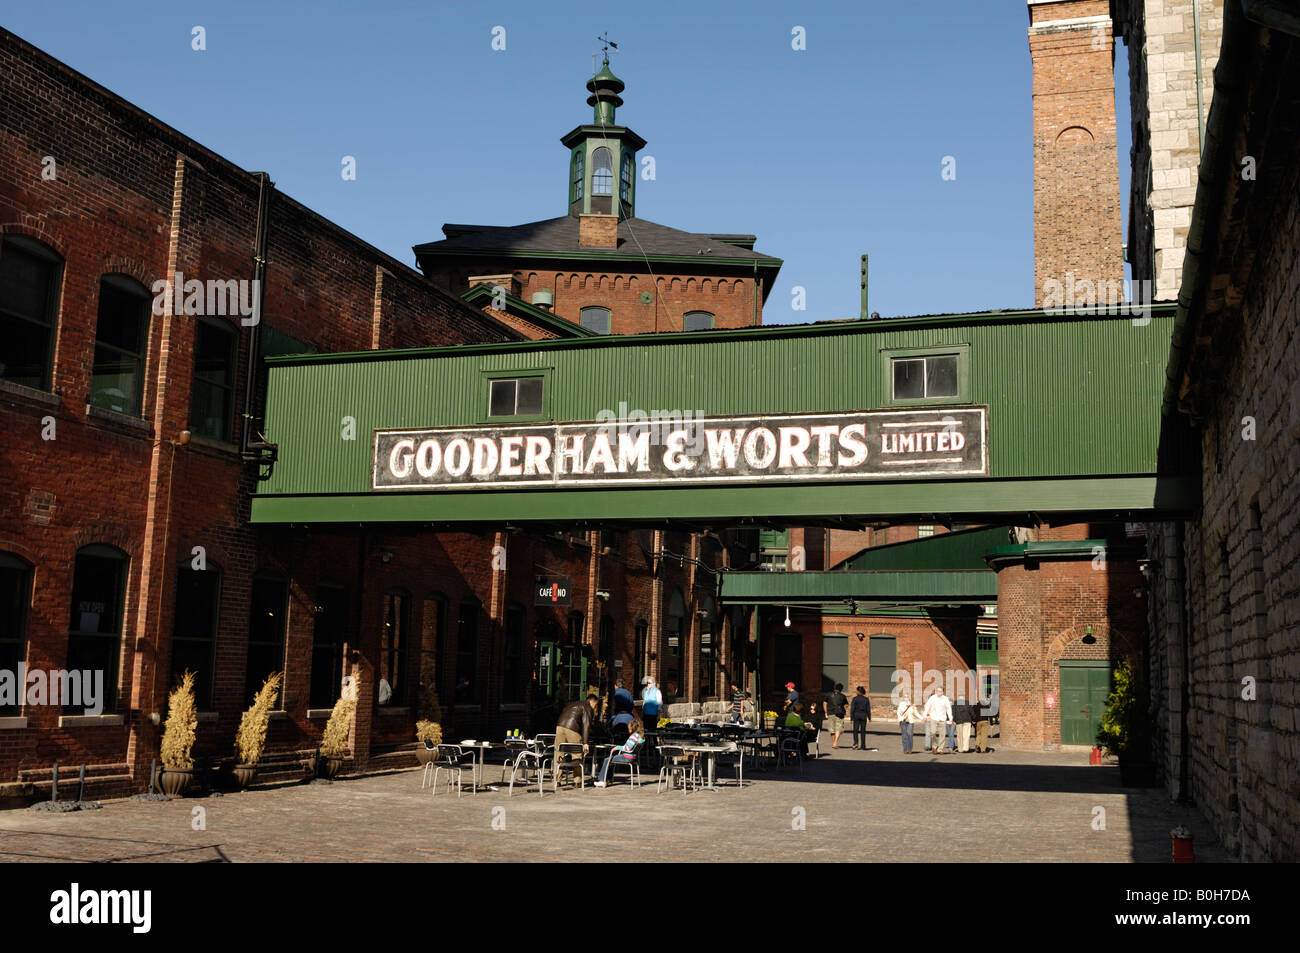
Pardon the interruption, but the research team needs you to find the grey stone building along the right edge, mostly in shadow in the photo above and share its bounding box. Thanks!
[1125,3,1300,861]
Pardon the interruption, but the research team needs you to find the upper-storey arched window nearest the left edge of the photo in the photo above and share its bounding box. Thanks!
[0,235,61,390]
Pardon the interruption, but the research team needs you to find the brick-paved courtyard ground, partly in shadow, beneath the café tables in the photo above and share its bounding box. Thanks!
[0,723,1231,863]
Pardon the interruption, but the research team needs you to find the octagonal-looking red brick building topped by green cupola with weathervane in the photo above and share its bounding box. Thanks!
[415,61,781,334]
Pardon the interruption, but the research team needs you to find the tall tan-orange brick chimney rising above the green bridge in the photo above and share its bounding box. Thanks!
[1028,0,1125,307]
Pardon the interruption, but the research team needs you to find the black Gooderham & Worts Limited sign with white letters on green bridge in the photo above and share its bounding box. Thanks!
[371,407,988,490]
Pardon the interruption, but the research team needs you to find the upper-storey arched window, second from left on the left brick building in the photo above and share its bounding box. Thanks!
[90,274,150,416]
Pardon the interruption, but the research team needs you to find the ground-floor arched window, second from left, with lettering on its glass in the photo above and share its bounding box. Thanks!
[64,545,127,714]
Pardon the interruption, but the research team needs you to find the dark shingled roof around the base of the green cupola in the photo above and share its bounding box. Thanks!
[415,215,780,264]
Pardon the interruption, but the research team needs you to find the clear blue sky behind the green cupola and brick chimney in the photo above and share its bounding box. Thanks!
[3,0,1128,324]
